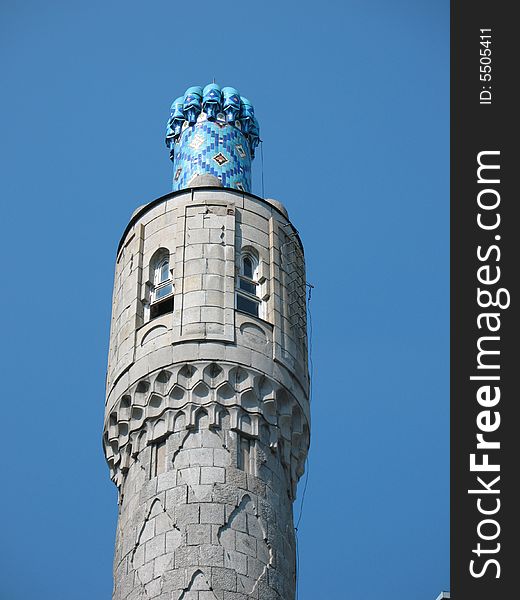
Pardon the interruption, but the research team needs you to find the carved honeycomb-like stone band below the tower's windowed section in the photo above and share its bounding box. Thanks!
[103,361,309,499]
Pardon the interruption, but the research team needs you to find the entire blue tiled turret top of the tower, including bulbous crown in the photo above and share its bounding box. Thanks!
[166,83,260,192]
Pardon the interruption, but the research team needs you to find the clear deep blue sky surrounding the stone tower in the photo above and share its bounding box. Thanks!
[0,0,449,600]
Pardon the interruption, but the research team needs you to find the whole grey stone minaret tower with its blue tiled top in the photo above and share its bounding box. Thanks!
[103,84,309,600]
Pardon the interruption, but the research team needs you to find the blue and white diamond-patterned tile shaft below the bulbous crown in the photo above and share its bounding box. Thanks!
[173,118,251,192]
